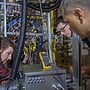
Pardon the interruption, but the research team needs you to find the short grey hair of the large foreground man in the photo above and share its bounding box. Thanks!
[62,0,90,10]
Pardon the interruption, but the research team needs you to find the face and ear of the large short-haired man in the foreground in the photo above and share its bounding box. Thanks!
[64,9,90,39]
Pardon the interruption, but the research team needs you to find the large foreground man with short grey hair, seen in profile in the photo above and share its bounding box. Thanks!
[61,0,90,47]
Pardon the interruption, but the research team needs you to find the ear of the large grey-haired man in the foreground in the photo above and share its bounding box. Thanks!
[74,8,84,24]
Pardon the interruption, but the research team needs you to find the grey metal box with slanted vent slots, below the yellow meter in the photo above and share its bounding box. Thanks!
[25,69,66,90]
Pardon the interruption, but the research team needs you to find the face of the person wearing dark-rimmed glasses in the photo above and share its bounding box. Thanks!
[56,22,71,37]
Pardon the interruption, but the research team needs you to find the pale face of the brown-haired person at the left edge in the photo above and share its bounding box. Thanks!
[1,47,14,62]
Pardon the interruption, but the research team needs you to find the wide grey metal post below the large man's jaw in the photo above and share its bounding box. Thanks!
[72,33,81,90]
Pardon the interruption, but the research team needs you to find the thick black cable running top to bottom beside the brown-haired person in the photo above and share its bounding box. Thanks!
[6,0,27,90]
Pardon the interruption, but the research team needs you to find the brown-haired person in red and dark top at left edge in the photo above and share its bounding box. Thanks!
[0,37,15,83]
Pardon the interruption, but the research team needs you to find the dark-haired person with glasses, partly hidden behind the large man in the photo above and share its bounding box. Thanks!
[56,16,71,37]
